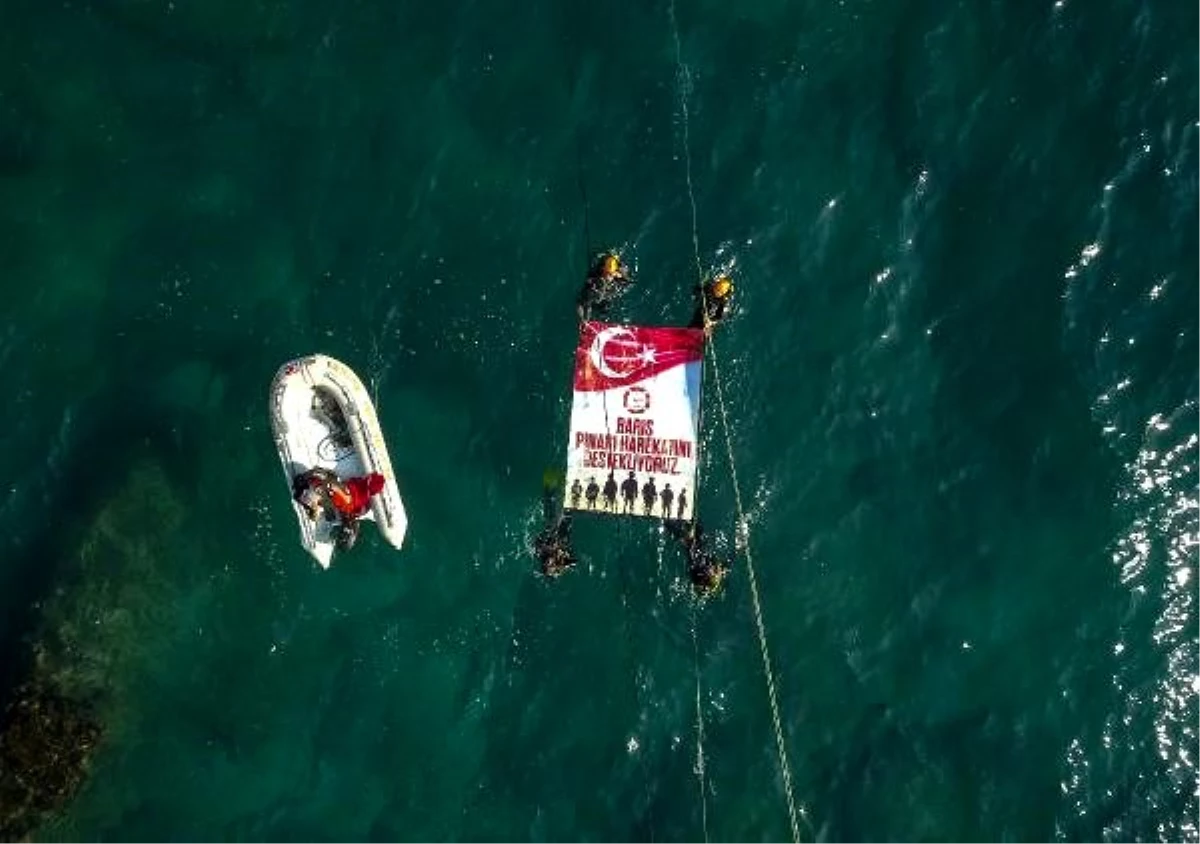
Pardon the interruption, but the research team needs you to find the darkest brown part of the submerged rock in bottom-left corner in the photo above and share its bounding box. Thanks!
[0,683,101,842]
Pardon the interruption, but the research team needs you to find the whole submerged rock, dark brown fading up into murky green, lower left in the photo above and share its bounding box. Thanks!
[0,459,185,844]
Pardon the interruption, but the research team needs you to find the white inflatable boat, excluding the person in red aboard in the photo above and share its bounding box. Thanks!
[271,354,408,568]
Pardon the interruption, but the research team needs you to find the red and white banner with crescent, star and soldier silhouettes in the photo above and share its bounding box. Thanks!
[564,322,704,519]
